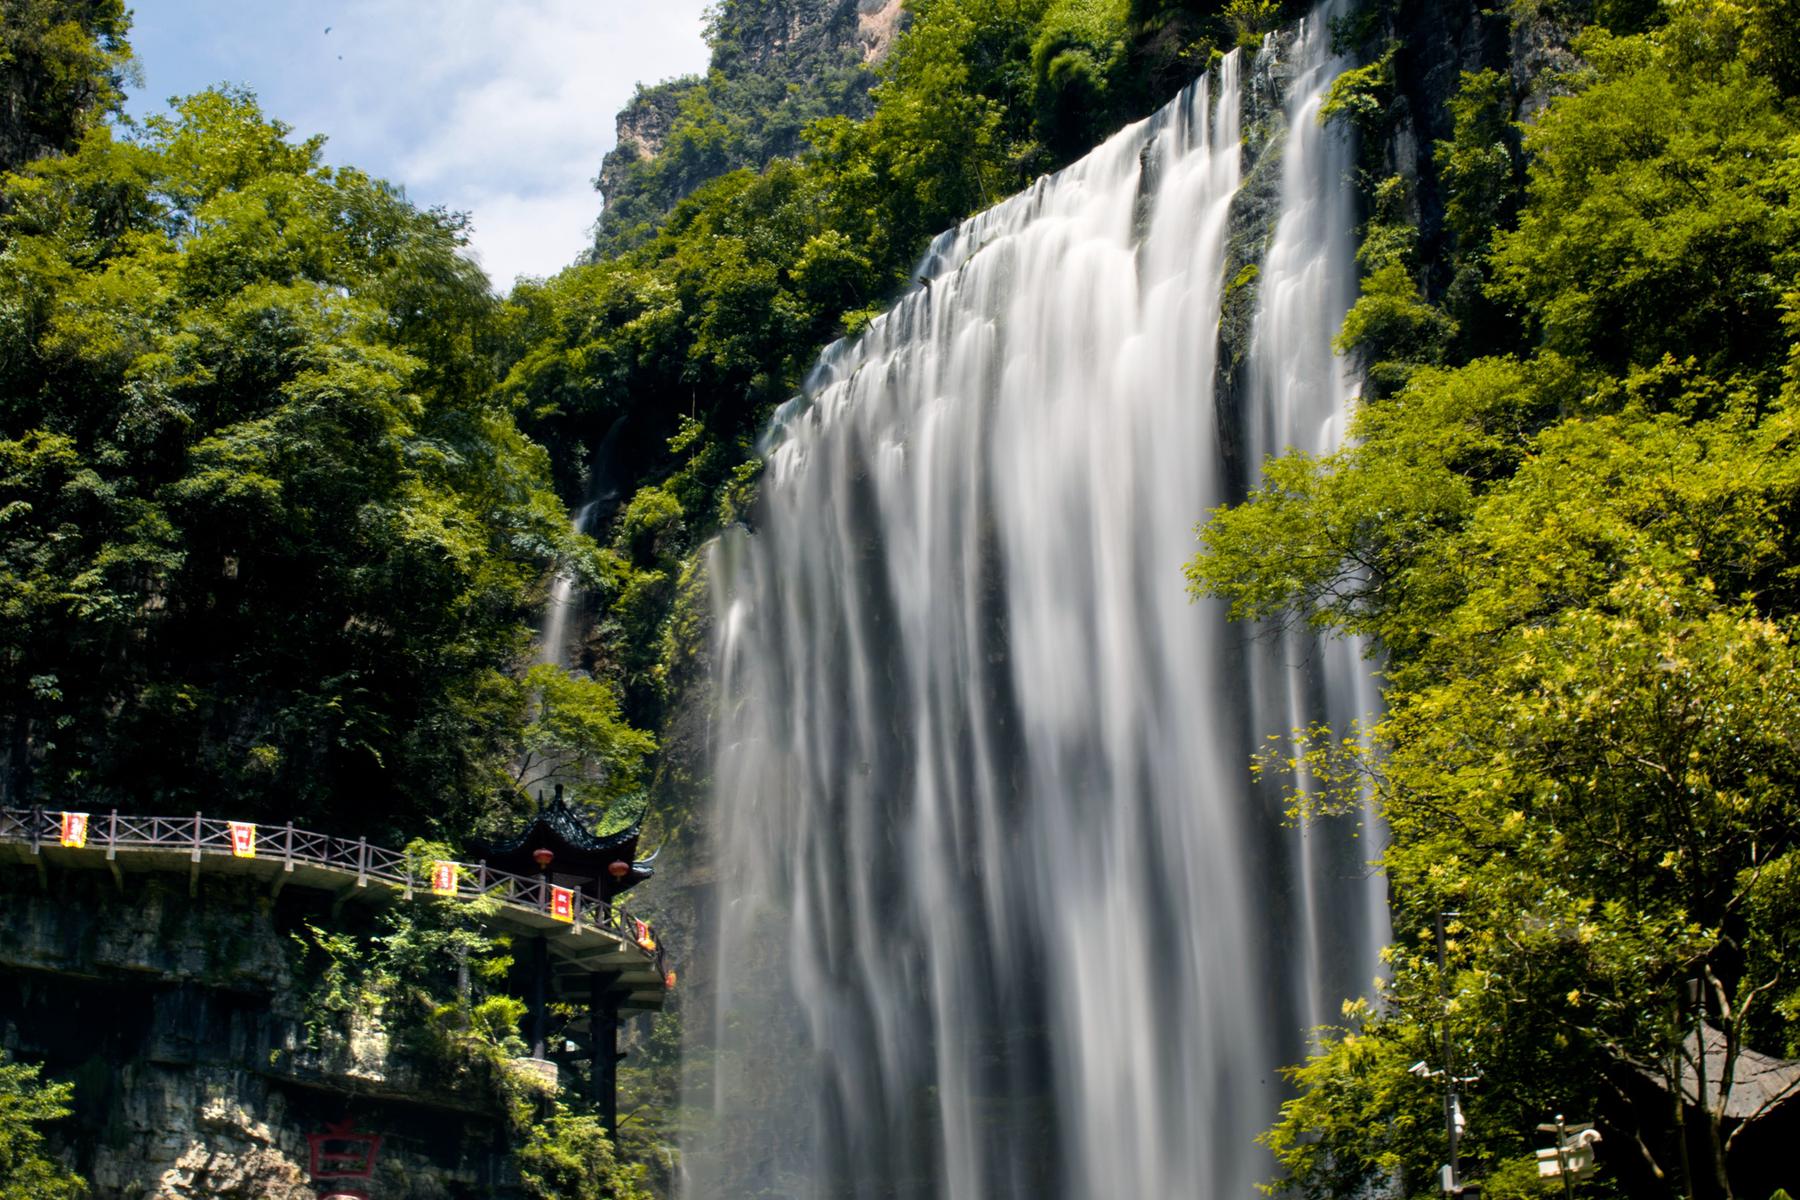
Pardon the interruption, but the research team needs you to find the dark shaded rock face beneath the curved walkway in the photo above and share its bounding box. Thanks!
[0,869,511,1200]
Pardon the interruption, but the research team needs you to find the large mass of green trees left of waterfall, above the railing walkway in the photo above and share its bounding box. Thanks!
[0,82,643,835]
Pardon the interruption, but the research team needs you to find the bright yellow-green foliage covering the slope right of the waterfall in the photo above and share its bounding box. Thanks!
[1190,2,1800,1196]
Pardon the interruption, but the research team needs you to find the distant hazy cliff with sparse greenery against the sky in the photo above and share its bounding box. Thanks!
[594,0,904,257]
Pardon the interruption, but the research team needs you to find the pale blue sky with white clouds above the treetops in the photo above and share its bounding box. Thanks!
[126,0,707,291]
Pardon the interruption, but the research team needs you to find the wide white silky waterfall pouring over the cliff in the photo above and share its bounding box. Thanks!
[686,7,1382,1200]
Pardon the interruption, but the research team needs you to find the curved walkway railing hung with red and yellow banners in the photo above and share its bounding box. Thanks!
[0,808,666,975]
